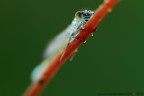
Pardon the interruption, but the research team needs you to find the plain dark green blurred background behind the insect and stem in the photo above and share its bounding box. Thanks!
[0,0,144,96]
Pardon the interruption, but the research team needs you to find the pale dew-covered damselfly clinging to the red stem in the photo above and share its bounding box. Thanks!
[31,10,94,81]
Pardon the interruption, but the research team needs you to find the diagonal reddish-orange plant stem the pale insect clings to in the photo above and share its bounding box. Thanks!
[23,0,119,96]
